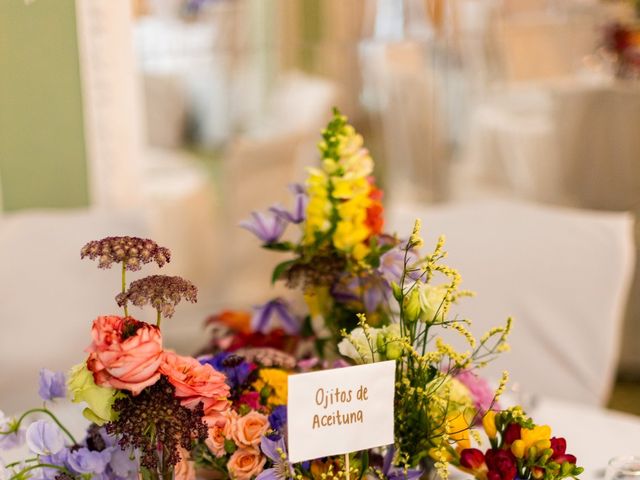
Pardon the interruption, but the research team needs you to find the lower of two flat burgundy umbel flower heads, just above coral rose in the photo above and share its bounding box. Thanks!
[116,275,198,318]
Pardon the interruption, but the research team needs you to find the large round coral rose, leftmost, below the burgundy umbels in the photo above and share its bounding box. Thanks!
[86,316,163,395]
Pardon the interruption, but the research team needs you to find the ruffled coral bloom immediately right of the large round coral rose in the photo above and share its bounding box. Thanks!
[160,352,229,415]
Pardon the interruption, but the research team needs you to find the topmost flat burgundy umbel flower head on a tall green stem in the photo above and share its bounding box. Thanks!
[80,237,171,271]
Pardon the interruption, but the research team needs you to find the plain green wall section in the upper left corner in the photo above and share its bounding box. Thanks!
[0,0,89,211]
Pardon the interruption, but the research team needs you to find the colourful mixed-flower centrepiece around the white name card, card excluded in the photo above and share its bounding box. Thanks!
[0,111,582,480]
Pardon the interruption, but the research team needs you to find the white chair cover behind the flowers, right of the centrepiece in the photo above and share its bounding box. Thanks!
[388,202,634,405]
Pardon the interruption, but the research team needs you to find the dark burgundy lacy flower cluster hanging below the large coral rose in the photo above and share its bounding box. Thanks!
[106,377,208,470]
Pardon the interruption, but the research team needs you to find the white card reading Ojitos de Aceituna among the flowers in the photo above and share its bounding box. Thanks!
[287,361,396,463]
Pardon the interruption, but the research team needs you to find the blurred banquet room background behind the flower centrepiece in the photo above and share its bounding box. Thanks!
[0,0,640,414]
